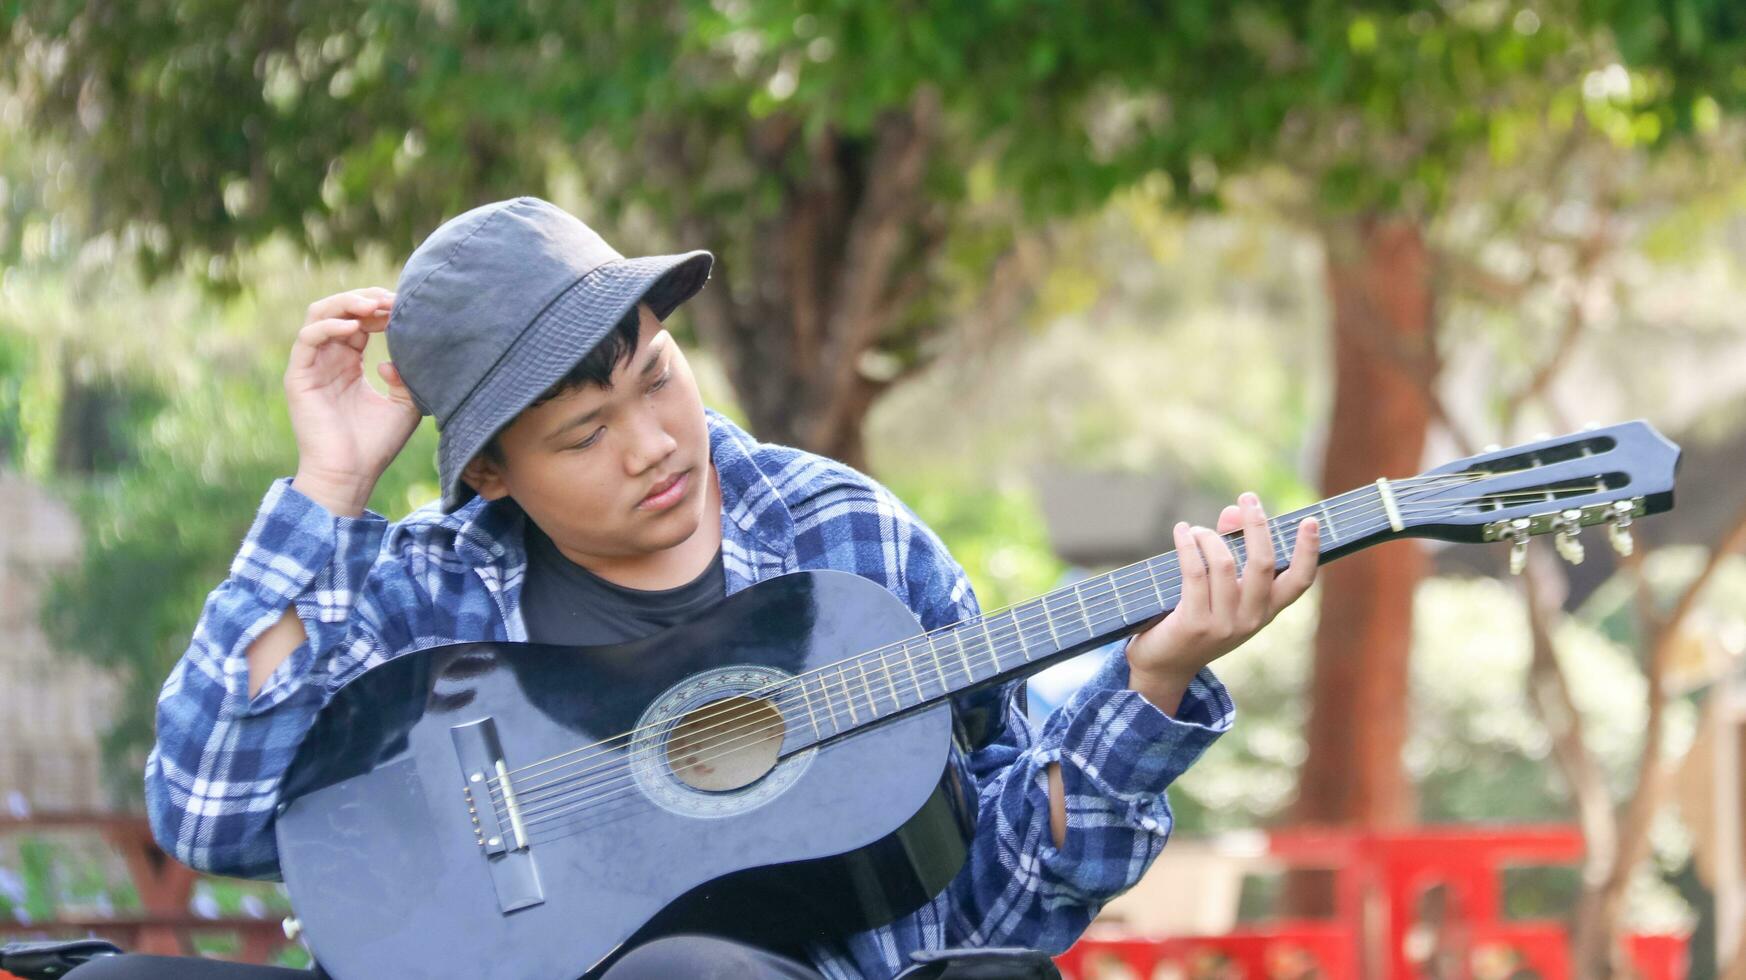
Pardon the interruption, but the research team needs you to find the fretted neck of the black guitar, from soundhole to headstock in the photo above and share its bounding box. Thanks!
[784,484,1397,753]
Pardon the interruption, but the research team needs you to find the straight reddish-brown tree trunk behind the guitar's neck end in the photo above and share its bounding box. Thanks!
[1287,218,1437,914]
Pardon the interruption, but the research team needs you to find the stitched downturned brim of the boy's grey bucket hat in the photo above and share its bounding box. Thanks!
[437,250,714,514]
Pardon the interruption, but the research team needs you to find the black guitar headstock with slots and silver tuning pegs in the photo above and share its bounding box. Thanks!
[1390,421,1680,571]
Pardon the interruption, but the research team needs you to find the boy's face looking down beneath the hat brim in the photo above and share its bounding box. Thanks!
[463,306,714,561]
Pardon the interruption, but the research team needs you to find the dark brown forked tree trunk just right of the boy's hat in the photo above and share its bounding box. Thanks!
[663,93,939,468]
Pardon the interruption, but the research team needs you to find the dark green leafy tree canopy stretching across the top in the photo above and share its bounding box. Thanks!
[0,0,1746,278]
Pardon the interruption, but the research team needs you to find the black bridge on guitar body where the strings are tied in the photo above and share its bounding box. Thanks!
[449,718,545,912]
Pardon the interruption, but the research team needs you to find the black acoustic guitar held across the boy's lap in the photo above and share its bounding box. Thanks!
[276,421,1680,980]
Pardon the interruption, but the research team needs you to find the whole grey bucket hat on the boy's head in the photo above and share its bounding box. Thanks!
[388,197,714,514]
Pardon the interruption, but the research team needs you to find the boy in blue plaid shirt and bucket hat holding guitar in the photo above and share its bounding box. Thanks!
[136,197,1316,980]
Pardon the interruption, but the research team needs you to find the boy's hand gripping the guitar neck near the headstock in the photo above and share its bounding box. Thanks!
[1128,493,1322,713]
